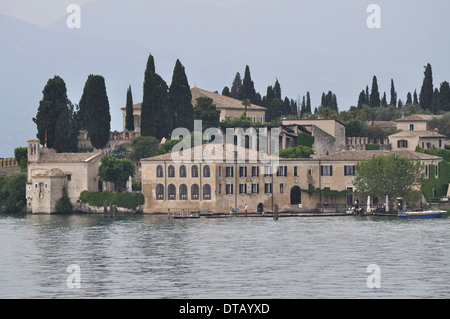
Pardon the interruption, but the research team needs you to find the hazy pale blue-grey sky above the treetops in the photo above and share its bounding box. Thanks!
[0,0,450,157]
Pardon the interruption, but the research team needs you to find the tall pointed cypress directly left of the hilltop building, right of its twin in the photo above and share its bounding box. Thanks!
[167,59,194,131]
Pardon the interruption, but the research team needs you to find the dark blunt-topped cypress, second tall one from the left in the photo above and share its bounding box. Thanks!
[80,74,111,149]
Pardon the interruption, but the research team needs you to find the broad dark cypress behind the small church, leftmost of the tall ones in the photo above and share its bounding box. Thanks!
[33,76,78,152]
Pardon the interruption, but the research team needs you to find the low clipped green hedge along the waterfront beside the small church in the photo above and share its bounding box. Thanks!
[80,191,145,210]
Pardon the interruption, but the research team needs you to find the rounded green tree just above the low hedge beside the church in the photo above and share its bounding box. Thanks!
[98,156,135,190]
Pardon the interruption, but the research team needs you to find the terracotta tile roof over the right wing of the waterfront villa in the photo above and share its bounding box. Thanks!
[317,150,442,161]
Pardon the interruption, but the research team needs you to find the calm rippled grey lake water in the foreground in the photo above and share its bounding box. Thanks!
[0,215,450,299]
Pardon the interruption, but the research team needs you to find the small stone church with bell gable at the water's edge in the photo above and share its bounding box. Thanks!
[26,140,102,214]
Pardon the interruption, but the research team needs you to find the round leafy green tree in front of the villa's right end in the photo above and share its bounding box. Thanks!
[353,154,423,208]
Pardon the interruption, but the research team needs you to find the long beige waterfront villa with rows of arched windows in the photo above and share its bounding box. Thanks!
[141,146,442,213]
